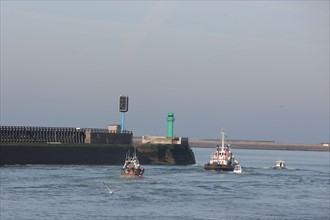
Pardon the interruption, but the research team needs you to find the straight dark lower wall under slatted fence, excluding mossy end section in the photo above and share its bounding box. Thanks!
[0,143,133,165]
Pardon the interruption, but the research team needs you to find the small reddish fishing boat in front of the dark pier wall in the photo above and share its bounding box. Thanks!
[121,151,144,178]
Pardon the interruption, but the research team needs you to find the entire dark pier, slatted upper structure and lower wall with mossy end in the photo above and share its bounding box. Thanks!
[0,126,195,165]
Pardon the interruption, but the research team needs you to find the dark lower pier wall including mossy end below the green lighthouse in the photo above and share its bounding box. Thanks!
[0,142,195,165]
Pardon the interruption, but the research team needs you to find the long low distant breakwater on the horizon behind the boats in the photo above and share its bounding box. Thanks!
[189,140,330,152]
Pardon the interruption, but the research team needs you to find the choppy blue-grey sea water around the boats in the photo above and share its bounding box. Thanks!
[0,148,330,220]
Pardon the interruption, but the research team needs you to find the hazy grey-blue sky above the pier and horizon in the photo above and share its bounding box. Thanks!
[1,0,330,143]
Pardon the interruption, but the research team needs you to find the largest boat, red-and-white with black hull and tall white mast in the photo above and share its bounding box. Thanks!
[204,131,239,171]
